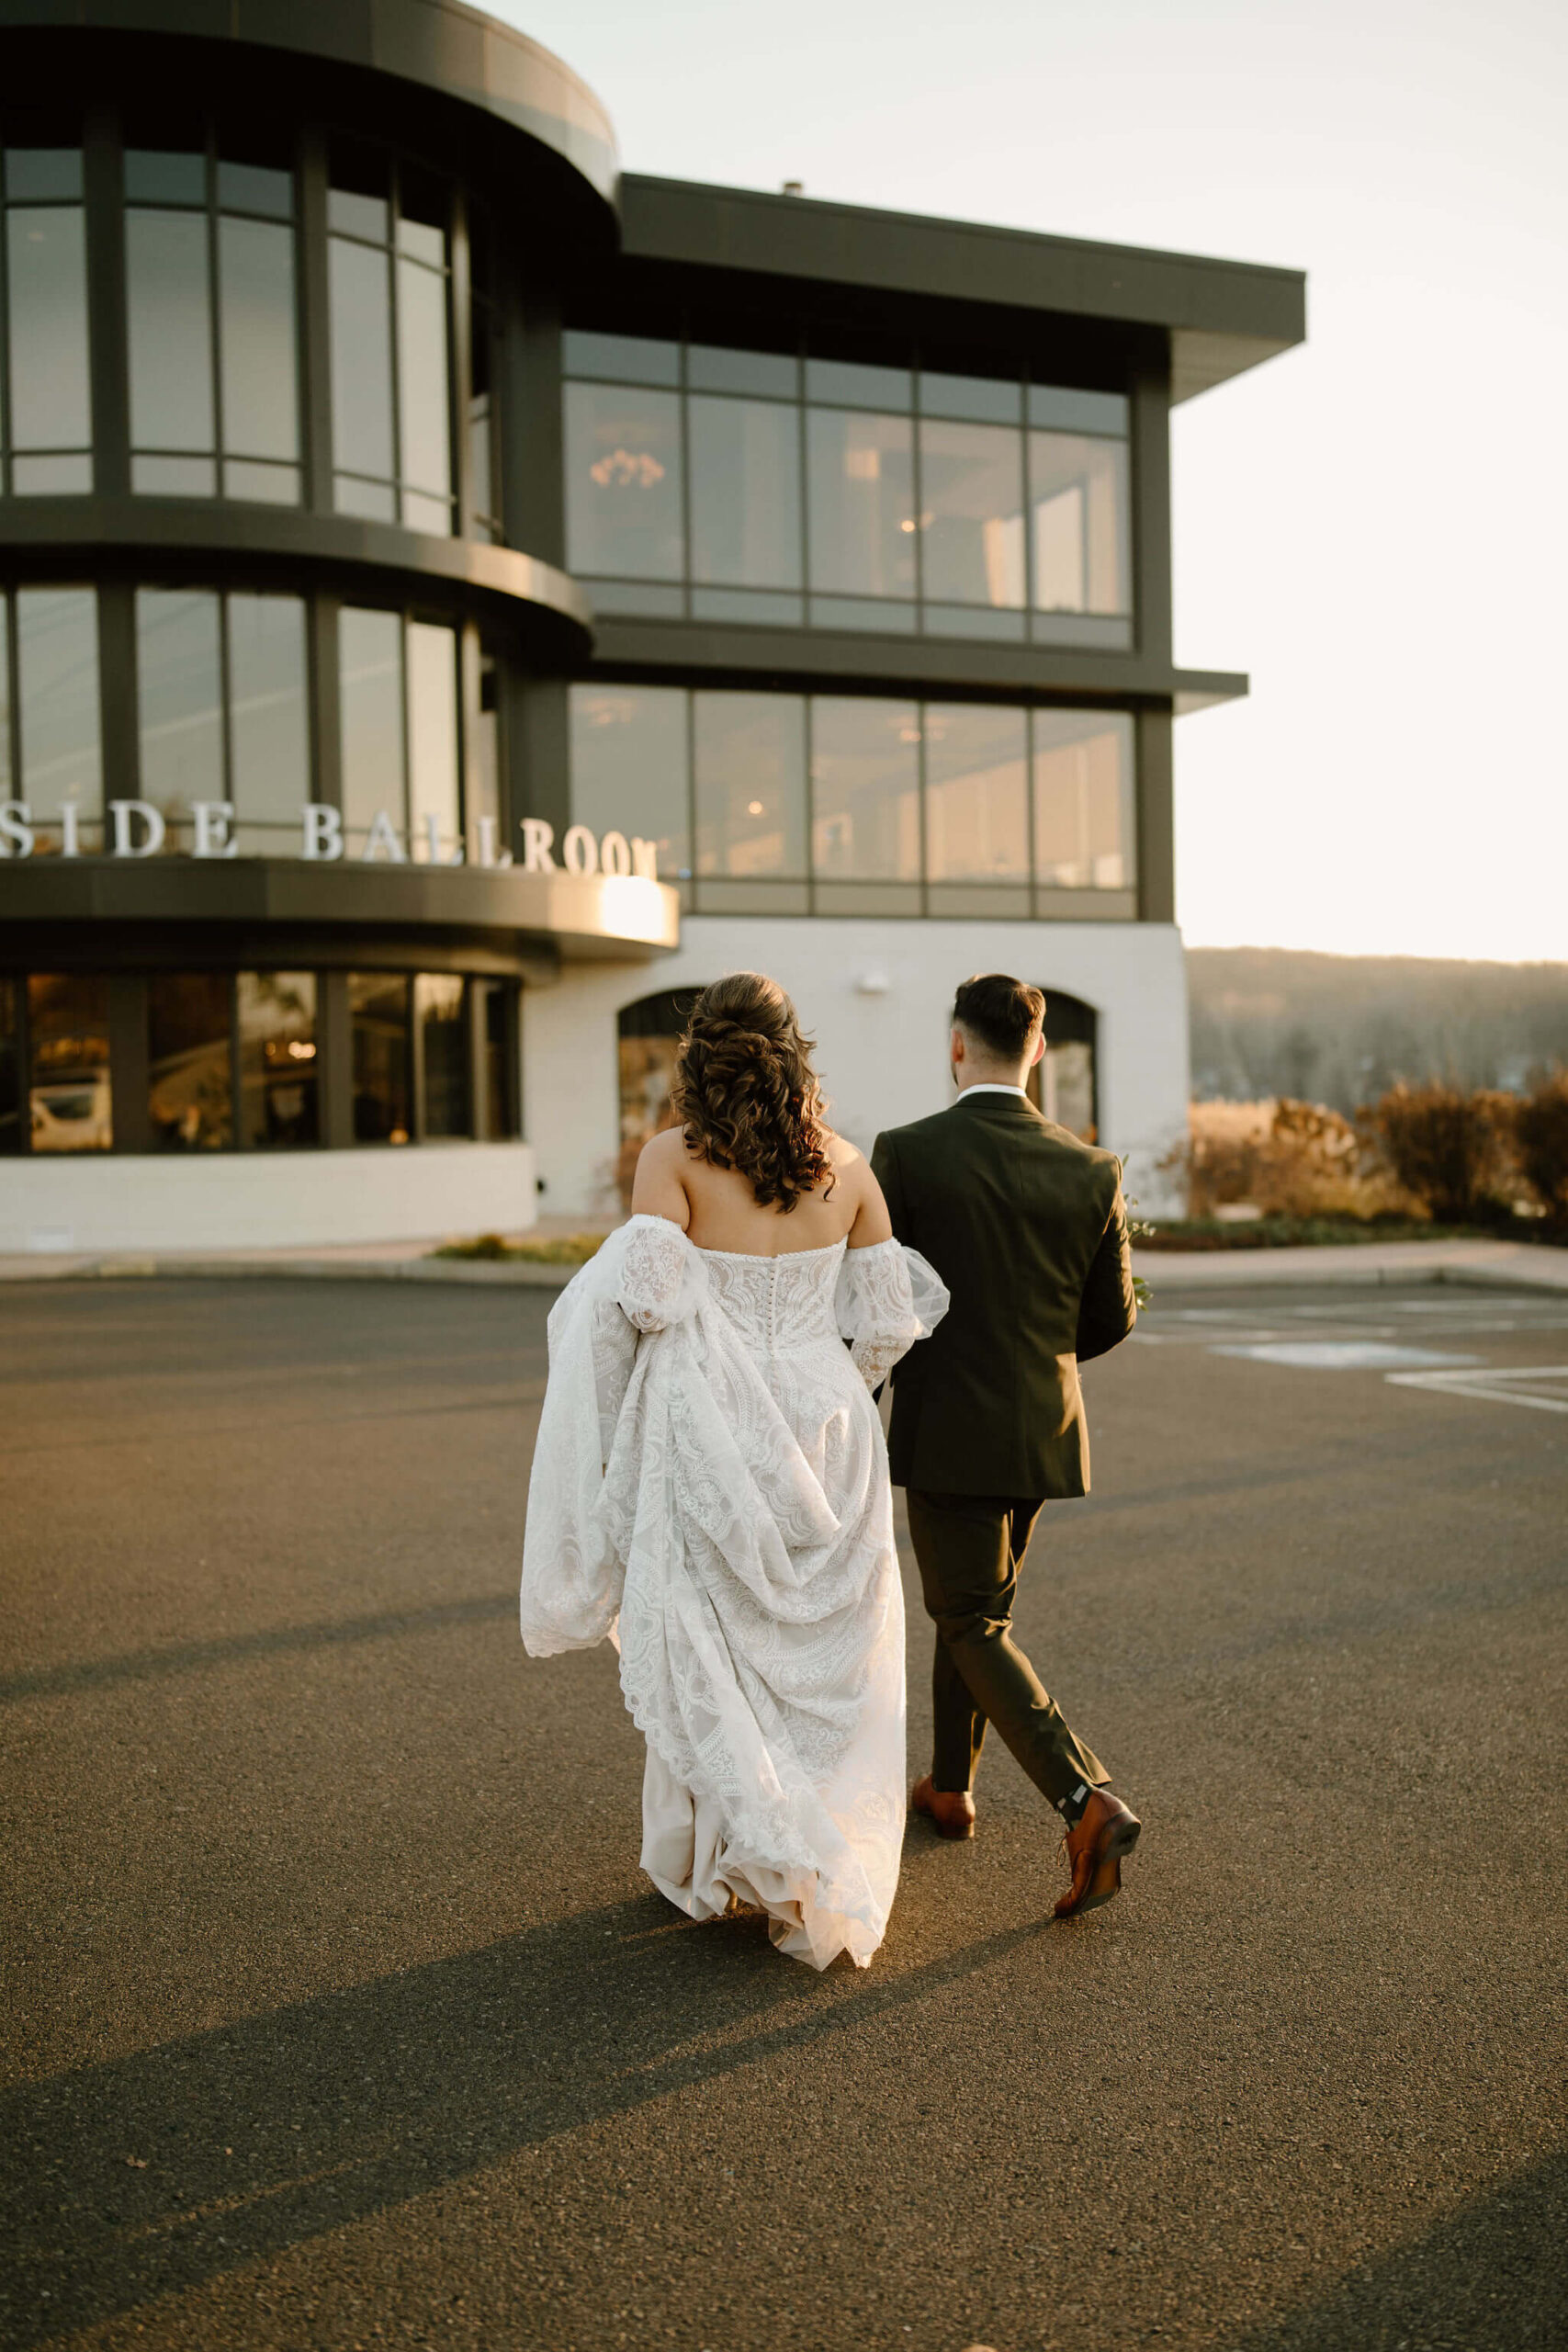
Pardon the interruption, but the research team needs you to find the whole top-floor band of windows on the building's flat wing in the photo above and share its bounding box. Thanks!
[564,332,1134,651]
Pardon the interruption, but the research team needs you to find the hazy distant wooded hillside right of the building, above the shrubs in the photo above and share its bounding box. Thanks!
[1187,948,1568,1114]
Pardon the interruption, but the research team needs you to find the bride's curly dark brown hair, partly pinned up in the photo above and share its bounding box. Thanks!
[670,971,832,1216]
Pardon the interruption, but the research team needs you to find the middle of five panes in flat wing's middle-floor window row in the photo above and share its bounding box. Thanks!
[811,694,919,882]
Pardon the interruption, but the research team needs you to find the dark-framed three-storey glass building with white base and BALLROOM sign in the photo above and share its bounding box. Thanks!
[0,0,1304,1249]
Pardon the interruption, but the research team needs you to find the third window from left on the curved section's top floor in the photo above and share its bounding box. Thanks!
[327,143,453,537]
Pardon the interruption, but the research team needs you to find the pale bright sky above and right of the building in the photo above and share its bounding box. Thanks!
[493,0,1568,959]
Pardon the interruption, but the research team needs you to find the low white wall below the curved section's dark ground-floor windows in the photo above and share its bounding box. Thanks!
[0,1143,536,1256]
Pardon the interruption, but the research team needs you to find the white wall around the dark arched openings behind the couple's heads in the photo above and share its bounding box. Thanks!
[522,915,1187,1216]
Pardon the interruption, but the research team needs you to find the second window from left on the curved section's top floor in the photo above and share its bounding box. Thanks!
[125,125,301,505]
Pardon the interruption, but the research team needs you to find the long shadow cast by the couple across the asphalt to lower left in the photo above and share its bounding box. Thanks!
[0,1832,1043,2345]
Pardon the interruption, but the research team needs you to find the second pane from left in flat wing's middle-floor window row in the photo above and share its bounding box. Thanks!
[691,694,807,879]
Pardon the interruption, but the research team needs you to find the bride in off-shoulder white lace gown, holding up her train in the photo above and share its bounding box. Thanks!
[522,971,947,1969]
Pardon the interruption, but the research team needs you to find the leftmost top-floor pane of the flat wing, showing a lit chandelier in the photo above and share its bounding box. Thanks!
[567,383,682,579]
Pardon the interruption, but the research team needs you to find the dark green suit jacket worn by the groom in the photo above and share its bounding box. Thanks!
[872,1093,1138,1496]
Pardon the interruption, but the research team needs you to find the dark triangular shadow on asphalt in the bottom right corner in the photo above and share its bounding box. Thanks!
[1227,2154,1568,2352]
